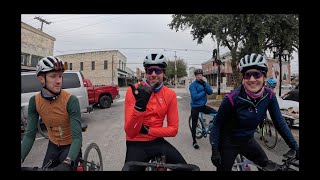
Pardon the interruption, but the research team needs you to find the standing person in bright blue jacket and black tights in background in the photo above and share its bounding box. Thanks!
[189,69,217,149]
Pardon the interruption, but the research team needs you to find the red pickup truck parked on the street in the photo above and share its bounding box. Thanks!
[84,78,120,109]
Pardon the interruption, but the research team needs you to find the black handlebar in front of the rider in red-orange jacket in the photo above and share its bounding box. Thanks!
[123,161,200,171]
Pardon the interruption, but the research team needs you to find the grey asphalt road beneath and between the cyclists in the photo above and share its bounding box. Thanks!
[22,88,299,171]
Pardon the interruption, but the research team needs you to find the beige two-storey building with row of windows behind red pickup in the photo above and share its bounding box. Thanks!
[57,50,127,87]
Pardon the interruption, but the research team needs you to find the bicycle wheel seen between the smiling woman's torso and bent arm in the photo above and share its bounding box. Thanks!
[263,119,278,149]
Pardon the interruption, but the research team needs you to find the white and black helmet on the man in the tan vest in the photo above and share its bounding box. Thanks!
[36,56,64,76]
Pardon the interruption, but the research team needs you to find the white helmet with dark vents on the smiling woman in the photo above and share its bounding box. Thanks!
[239,53,268,75]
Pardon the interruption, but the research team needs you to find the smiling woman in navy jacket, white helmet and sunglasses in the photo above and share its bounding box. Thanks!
[209,53,299,171]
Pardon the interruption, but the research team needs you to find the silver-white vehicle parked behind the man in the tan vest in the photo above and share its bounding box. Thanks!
[21,70,93,119]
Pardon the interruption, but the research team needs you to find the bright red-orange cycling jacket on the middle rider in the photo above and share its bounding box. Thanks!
[124,82,179,141]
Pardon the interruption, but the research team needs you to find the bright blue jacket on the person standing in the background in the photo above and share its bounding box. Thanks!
[189,80,213,107]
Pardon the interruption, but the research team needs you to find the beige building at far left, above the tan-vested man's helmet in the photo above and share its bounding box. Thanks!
[21,22,56,71]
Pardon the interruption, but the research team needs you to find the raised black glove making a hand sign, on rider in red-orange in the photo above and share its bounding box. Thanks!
[128,82,159,112]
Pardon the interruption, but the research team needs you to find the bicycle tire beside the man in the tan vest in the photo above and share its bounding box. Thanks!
[83,143,103,171]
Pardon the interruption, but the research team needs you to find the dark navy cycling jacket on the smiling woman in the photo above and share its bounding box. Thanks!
[210,85,299,150]
